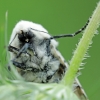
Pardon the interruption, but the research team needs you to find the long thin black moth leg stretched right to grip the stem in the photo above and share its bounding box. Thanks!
[50,17,91,39]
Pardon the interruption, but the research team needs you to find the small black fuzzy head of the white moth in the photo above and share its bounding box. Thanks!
[18,30,34,42]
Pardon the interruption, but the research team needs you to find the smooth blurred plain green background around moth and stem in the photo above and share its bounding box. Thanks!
[0,0,100,100]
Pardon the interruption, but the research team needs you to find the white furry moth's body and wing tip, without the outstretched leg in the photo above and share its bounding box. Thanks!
[8,20,89,100]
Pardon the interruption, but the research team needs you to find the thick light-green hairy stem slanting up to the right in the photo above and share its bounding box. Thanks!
[64,2,100,86]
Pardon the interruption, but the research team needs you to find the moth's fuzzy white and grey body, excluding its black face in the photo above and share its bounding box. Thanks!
[9,21,68,83]
